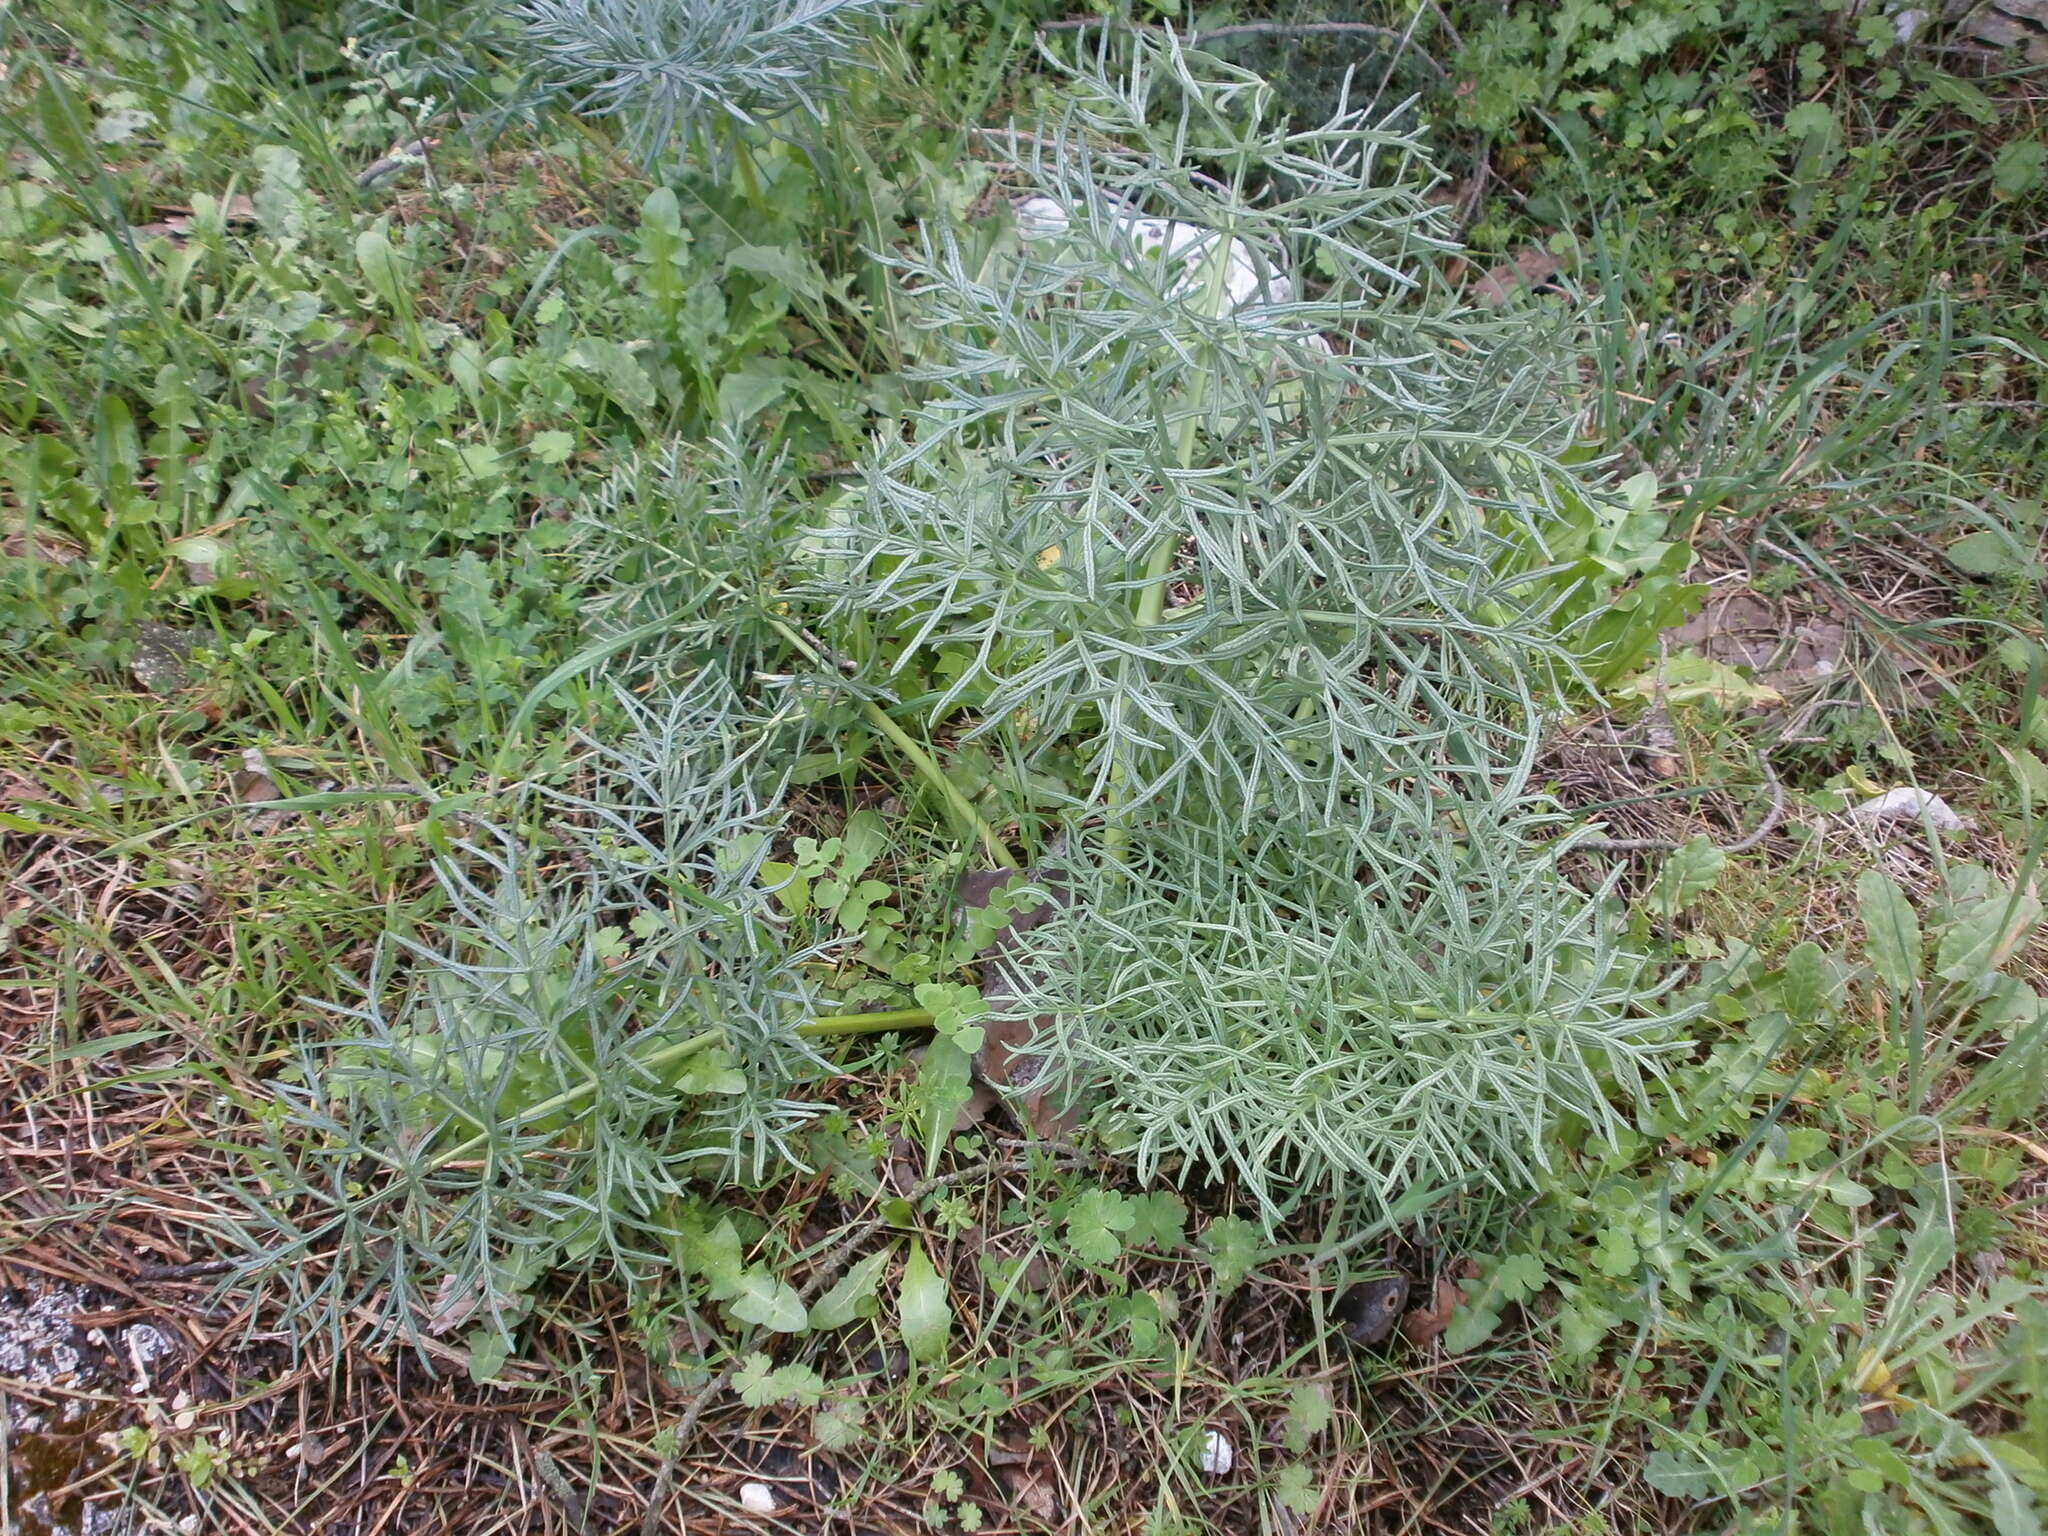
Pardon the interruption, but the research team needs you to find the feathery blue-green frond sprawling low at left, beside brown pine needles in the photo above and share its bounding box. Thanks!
[248,668,839,1333]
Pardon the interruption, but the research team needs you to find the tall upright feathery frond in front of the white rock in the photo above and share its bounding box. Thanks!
[817,41,1575,815]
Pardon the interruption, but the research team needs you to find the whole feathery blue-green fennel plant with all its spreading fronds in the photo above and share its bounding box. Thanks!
[256,27,1671,1327]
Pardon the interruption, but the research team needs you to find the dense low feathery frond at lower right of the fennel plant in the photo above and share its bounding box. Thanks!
[1004,786,1679,1219]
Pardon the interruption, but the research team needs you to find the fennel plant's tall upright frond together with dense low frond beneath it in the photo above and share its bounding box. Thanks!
[790,41,1663,1217]
